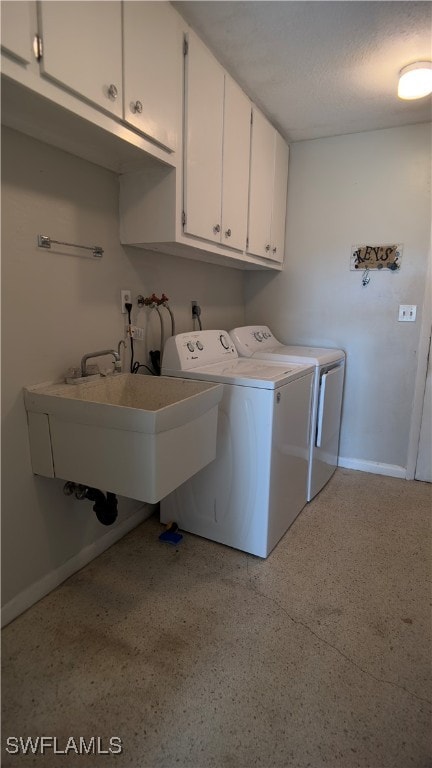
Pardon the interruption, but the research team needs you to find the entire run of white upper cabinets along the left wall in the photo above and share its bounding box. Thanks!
[1,0,288,269]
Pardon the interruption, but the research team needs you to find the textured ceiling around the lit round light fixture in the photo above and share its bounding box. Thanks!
[173,0,432,141]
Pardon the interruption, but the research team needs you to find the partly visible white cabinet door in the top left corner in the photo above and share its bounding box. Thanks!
[1,0,36,64]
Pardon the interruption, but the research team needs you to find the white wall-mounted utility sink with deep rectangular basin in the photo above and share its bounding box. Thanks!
[24,373,223,503]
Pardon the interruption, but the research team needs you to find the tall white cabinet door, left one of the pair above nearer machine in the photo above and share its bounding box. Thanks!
[184,33,224,242]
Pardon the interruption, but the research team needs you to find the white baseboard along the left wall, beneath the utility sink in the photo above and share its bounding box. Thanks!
[1,504,153,627]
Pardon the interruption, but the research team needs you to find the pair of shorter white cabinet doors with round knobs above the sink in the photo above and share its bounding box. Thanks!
[34,0,184,151]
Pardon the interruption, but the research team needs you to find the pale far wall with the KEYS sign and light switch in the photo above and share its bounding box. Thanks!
[245,124,431,476]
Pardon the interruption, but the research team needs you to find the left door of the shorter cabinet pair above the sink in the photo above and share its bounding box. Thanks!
[39,0,123,117]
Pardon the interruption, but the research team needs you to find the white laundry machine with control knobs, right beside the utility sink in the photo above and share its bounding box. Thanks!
[160,331,314,557]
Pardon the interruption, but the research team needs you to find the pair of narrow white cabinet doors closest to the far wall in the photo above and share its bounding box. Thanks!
[247,108,289,262]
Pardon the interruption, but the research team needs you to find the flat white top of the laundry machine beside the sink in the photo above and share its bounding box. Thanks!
[162,358,314,389]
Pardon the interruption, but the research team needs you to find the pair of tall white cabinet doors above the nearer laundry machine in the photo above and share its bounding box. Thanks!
[184,33,250,250]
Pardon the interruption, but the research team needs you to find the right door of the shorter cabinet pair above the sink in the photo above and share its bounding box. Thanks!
[123,0,183,151]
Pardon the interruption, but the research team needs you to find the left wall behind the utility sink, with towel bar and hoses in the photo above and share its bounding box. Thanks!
[2,128,244,620]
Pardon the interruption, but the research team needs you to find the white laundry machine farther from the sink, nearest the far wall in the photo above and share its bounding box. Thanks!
[230,325,345,501]
